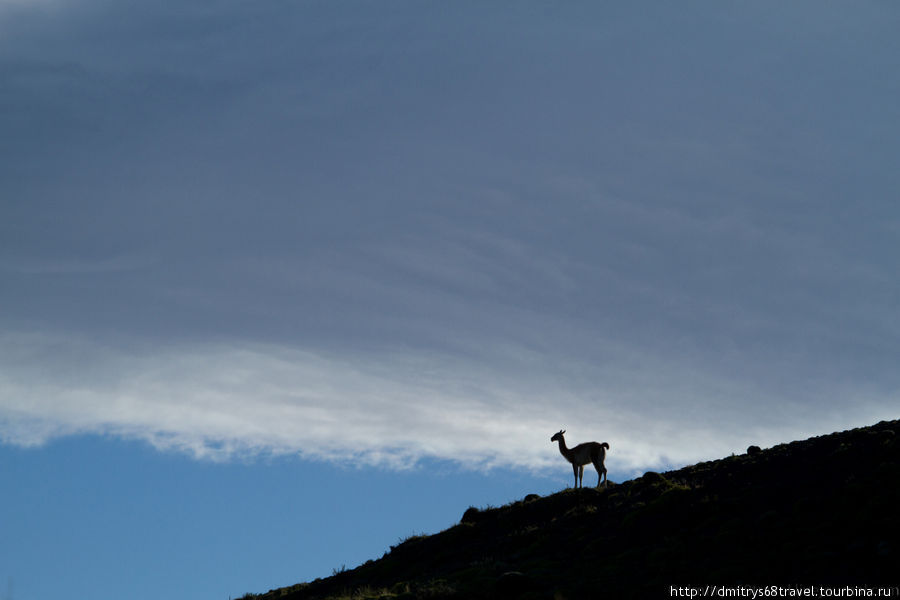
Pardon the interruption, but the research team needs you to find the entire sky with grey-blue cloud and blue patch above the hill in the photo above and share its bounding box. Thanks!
[0,0,900,600]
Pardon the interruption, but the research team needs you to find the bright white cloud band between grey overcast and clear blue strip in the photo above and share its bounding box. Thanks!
[0,334,890,475]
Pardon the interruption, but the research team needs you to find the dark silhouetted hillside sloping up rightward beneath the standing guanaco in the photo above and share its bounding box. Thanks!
[247,421,900,600]
